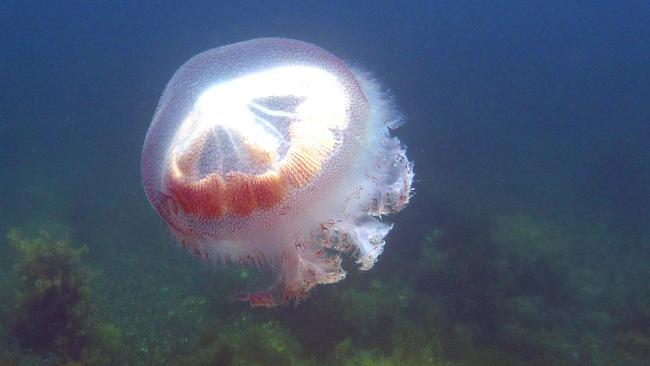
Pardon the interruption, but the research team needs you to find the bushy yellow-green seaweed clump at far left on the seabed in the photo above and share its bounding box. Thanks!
[7,229,122,364]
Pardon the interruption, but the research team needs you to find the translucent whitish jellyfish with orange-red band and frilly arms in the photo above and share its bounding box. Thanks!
[141,38,413,307]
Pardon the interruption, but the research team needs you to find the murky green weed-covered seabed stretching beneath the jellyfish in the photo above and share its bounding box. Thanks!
[0,190,650,365]
